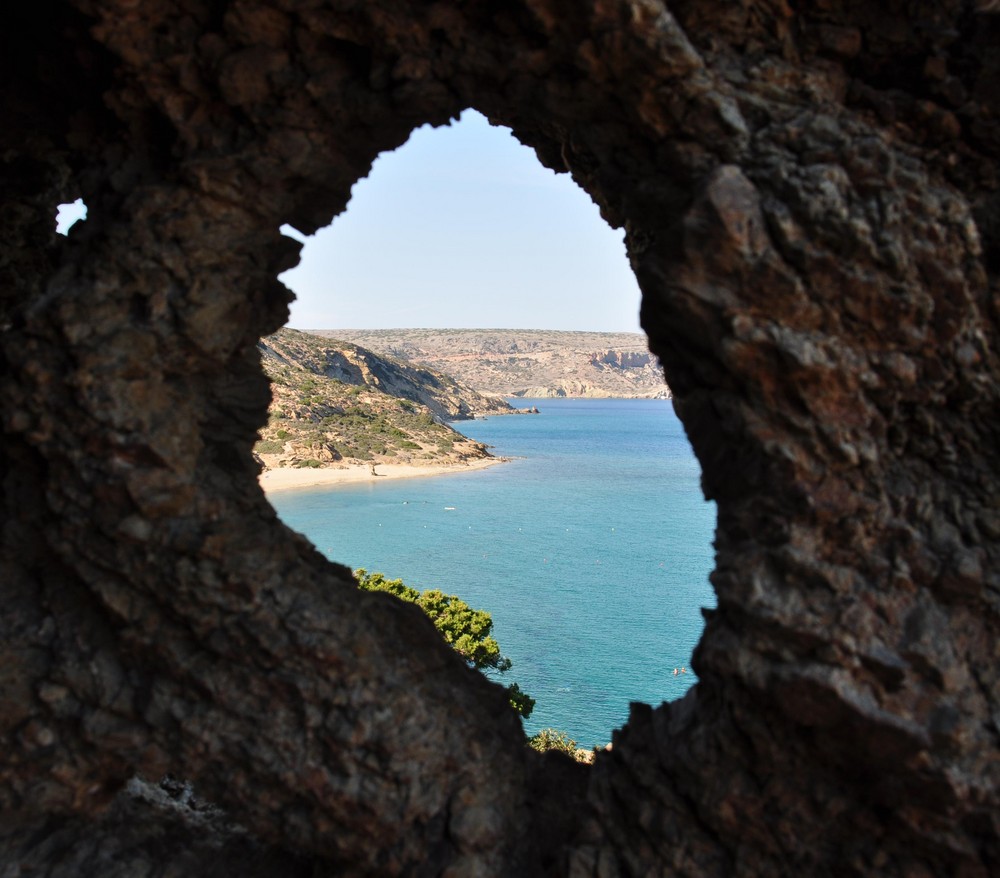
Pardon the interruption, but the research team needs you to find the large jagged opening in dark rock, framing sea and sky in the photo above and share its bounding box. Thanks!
[256,111,716,747]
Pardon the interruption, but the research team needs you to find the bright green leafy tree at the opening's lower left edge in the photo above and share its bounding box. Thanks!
[354,567,535,719]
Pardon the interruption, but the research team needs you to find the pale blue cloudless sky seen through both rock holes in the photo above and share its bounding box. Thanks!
[58,110,641,332]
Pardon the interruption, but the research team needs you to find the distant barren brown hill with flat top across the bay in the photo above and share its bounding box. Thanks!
[314,329,670,397]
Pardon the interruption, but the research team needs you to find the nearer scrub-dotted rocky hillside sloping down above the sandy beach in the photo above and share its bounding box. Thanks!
[254,329,511,469]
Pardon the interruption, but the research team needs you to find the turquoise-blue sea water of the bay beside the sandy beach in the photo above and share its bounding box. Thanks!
[270,399,715,746]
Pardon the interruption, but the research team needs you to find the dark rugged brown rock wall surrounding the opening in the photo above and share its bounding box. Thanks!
[0,0,1000,878]
